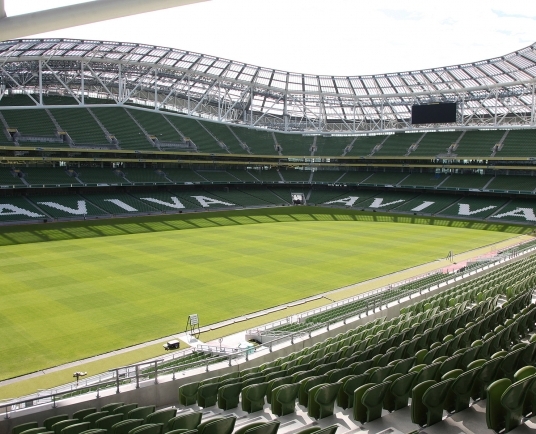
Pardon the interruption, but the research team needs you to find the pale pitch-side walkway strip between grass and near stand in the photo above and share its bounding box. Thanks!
[0,235,534,390]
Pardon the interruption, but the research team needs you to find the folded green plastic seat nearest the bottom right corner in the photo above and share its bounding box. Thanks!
[486,377,534,432]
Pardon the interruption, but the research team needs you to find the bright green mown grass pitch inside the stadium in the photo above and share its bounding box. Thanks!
[0,208,526,379]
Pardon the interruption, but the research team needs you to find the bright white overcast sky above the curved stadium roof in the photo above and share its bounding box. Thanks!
[5,0,536,76]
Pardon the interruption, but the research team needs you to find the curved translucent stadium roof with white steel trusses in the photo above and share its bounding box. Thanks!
[0,39,536,133]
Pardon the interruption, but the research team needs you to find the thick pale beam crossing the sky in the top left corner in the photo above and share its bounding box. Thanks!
[0,0,208,41]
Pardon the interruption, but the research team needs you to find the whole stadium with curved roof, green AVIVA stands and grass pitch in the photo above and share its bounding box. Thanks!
[0,0,536,434]
